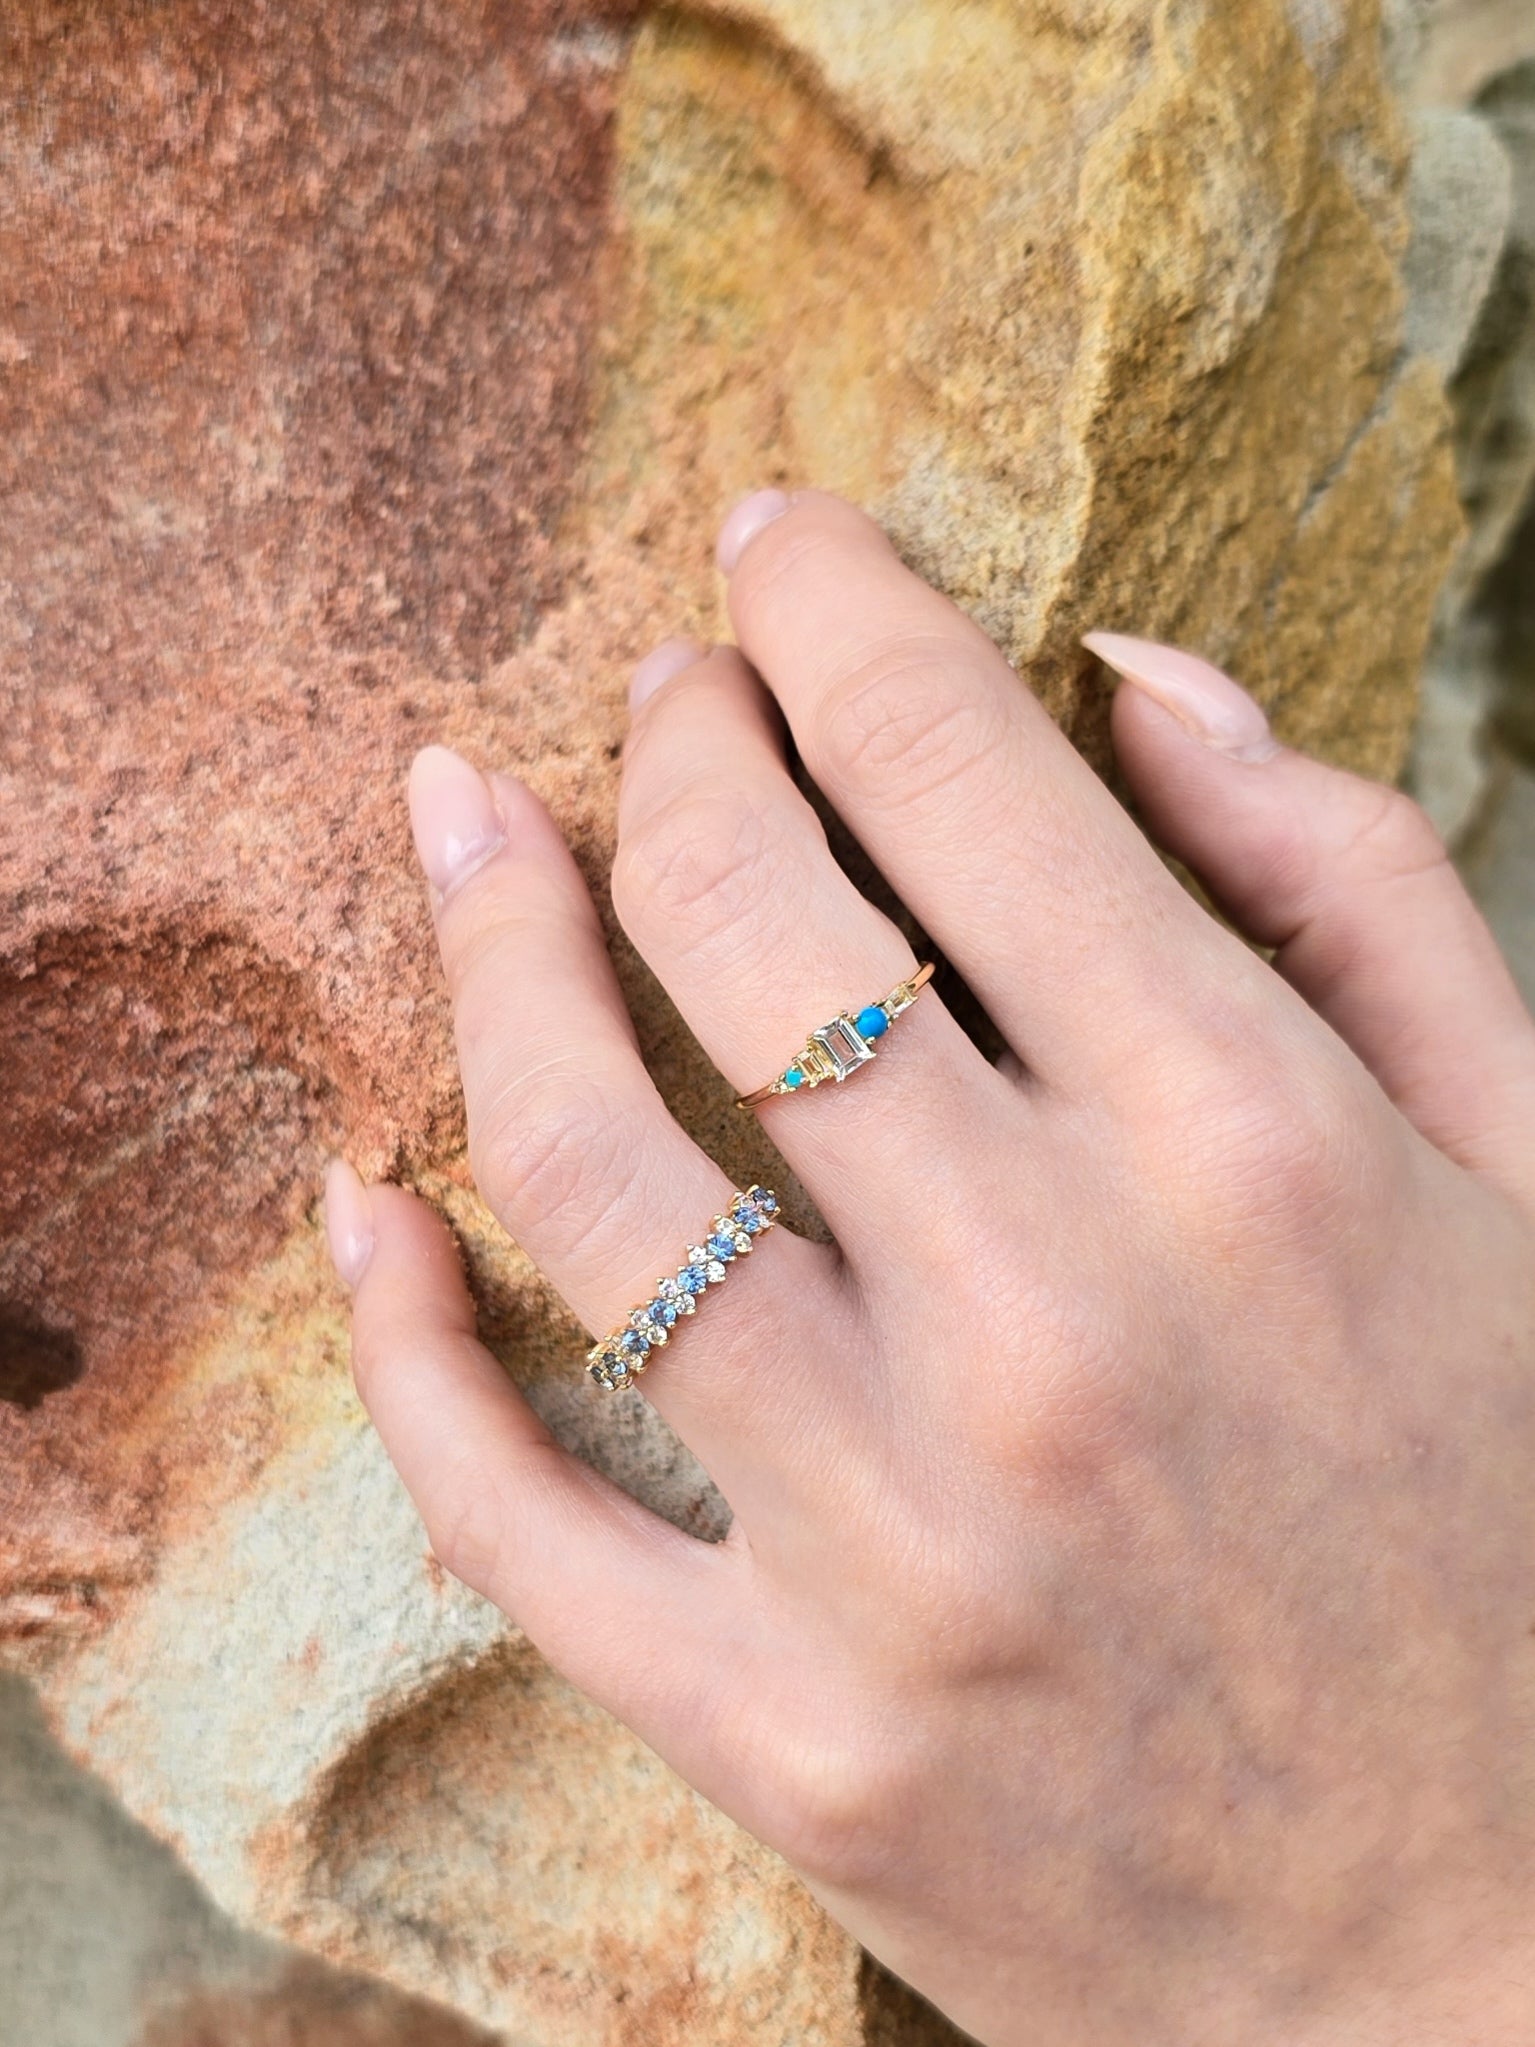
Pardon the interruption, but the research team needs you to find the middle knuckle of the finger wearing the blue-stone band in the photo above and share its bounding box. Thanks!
[469,1073,628,1255]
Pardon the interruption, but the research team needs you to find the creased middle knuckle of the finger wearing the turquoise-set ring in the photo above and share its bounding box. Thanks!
[612,792,772,942]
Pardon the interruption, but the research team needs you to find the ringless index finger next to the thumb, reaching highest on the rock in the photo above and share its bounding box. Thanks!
[720,491,1248,1095]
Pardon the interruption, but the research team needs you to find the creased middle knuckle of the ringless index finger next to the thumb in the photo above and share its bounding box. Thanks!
[815,641,1003,802]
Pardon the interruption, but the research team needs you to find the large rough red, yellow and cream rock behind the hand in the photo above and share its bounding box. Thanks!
[0,0,1481,2047]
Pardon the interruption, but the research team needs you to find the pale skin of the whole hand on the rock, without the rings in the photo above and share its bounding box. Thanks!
[330,491,1535,2047]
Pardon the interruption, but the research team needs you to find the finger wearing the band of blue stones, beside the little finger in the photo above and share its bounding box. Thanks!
[411,747,837,1509]
